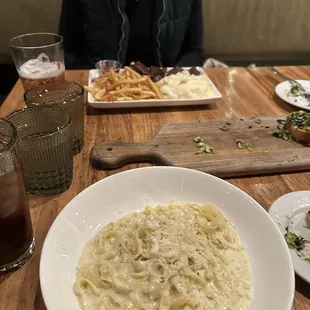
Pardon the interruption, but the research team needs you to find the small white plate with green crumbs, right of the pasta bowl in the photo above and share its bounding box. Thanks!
[269,191,310,283]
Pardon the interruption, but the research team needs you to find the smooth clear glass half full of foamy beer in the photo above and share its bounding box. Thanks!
[9,33,65,90]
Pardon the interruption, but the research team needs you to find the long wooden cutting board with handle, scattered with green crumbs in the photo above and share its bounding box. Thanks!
[90,117,310,177]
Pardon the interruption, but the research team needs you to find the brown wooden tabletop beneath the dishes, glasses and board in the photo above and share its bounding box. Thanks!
[0,67,310,310]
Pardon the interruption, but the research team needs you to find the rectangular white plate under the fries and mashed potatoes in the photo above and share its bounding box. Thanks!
[87,67,222,109]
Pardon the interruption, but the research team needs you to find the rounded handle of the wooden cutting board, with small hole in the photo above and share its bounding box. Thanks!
[90,141,173,170]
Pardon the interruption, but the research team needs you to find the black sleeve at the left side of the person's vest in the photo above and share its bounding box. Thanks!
[59,0,89,69]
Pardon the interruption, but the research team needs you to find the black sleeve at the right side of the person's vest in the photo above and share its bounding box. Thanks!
[177,0,204,67]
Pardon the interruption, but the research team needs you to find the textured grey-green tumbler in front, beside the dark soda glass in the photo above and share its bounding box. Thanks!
[8,107,73,195]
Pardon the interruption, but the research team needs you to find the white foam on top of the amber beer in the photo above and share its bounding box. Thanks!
[18,53,65,79]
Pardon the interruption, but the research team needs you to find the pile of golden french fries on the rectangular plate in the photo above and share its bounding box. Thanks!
[85,67,164,101]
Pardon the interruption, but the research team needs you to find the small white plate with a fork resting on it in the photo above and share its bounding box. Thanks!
[275,80,310,111]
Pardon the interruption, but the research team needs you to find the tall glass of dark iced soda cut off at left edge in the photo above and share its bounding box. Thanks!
[0,118,35,274]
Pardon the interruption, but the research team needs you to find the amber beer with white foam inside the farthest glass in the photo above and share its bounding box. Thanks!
[18,60,65,91]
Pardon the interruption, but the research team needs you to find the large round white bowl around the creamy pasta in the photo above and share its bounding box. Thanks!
[40,167,294,310]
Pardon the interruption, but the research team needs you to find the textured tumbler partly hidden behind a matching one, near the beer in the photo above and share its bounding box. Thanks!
[24,81,84,155]
